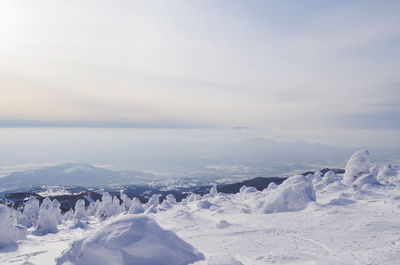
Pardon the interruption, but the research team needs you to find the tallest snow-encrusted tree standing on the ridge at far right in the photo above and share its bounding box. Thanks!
[343,150,370,186]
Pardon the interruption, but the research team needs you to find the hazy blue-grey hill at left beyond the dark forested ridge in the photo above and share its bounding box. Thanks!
[0,163,156,191]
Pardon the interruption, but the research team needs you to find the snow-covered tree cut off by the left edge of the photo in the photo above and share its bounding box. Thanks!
[0,204,26,248]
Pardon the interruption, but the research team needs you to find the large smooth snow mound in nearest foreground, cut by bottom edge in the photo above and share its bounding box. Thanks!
[57,215,204,265]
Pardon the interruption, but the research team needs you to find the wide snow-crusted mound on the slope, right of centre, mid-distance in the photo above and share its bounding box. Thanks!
[261,175,315,213]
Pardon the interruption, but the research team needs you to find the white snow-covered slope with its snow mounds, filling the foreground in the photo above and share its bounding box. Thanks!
[0,152,400,265]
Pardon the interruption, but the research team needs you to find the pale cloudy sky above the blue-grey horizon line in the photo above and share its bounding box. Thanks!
[0,0,400,129]
